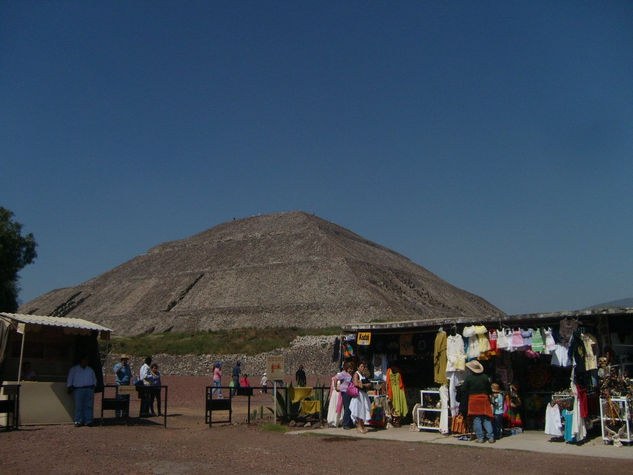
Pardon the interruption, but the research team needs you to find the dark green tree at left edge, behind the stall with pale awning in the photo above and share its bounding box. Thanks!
[0,206,37,312]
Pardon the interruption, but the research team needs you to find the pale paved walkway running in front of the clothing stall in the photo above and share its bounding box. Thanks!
[288,427,633,460]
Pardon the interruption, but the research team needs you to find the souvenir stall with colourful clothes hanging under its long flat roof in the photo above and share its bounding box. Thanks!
[346,309,633,442]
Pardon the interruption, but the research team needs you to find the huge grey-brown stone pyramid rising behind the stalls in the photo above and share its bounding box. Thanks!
[20,211,504,335]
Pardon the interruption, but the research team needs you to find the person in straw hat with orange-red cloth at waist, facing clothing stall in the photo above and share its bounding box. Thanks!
[462,360,495,444]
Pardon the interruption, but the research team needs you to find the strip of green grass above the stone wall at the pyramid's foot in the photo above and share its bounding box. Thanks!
[110,327,342,356]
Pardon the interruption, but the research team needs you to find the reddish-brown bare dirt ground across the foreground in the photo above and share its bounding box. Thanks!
[0,377,631,475]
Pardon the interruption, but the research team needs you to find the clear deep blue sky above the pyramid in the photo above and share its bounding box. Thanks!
[0,0,633,313]
